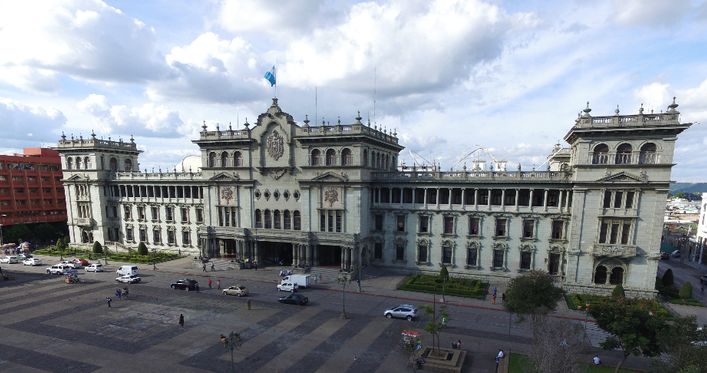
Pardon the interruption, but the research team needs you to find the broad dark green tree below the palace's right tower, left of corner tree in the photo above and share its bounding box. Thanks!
[590,298,666,372]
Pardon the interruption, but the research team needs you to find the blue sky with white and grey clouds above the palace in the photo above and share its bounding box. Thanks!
[0,0,707,182]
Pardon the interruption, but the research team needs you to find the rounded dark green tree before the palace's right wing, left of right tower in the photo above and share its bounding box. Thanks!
[504,271,562,321]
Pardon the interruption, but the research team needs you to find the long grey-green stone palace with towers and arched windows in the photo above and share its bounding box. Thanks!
[57,99,691,296]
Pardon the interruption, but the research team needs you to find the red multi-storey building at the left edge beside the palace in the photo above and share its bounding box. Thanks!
[0,148,66,226]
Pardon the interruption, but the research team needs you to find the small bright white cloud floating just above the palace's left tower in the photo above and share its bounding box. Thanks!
[77,94,191,137]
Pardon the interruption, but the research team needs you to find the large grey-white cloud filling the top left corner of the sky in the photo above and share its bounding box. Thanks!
[0,0,163,90]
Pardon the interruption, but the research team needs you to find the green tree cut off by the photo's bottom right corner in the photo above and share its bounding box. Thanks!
[653,316,707,373]
